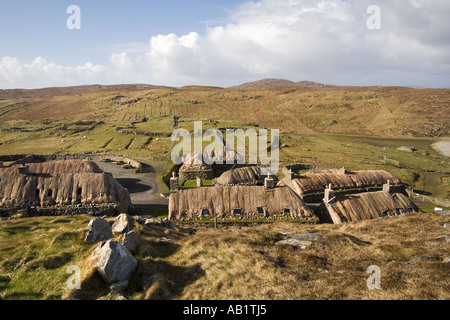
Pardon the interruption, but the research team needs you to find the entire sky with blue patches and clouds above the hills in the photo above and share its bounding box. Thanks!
[0,0,450,89]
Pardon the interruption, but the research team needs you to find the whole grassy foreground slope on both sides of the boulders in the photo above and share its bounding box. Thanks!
[0,214,450,300]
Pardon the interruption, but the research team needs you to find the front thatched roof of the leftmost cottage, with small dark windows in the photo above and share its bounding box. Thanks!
[0,170,131,211]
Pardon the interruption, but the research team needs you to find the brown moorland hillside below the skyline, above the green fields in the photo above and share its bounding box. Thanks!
[0,80,450,137]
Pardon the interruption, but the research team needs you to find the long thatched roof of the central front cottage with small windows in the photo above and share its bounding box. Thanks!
[169,186,313,219]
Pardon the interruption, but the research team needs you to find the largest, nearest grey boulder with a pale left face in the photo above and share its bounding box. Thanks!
[92,240,138,284]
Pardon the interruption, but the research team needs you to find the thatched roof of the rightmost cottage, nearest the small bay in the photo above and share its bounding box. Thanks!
[320,191,420,224]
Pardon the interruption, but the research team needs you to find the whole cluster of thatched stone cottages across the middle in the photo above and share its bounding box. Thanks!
[0,140,420,224]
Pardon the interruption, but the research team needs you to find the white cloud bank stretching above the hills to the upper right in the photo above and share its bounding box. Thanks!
[0,0,450,88]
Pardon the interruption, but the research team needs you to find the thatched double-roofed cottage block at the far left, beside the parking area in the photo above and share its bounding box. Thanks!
[0,160,131,212]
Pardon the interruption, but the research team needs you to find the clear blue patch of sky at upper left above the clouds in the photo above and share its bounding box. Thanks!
[0,0,241,65]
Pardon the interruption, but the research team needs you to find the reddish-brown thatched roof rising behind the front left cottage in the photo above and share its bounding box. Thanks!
[0,160,103,174]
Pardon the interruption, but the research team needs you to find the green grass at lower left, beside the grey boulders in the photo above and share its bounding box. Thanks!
[0,216,92,300]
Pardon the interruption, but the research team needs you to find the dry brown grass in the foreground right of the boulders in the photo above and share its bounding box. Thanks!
[170,214,450,300]
